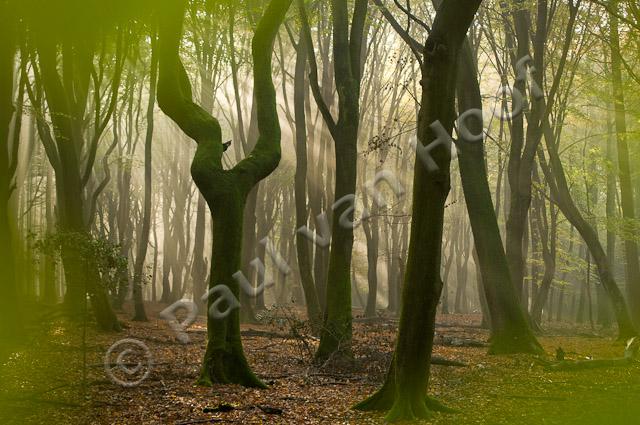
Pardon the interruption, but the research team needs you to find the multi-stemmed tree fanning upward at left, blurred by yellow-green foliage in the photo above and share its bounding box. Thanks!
[22,2,137,330]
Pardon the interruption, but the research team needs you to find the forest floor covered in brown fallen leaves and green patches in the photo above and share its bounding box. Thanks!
[0,305,640,425]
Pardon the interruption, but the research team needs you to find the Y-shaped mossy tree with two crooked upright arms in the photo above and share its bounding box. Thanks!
[158,0,291,387]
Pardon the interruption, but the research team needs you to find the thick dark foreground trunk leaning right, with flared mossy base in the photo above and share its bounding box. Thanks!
[356,0,480,421]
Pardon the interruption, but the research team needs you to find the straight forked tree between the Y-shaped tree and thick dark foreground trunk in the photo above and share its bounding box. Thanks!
[298,0,368,361]
